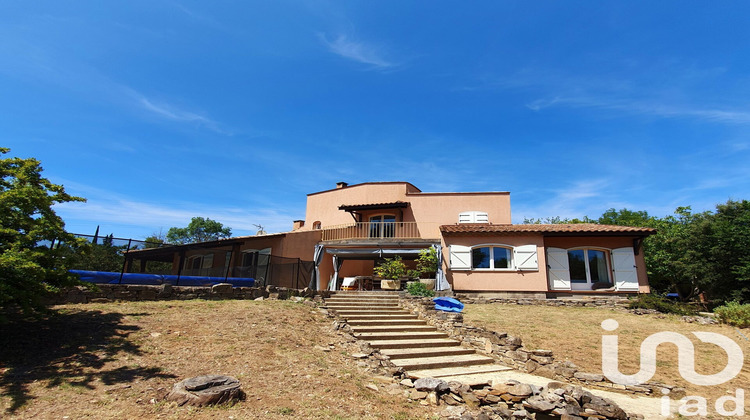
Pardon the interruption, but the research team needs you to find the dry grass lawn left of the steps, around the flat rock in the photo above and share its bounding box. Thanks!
[0,300,440,419]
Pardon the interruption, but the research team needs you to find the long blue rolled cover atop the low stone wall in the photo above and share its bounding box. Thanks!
[68,270,255,287]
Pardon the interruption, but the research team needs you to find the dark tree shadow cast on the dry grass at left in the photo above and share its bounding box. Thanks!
[0,310,175,416]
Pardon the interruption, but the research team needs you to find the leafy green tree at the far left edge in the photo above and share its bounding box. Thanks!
[0,148,85,313]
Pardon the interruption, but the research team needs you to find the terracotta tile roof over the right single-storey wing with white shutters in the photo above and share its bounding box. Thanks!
[440,223,656,236]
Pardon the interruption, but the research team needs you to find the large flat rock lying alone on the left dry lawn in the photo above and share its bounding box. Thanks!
[166,375,245,406]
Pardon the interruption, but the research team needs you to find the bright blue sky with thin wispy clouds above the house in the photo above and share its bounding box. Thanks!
[0,0,750,238]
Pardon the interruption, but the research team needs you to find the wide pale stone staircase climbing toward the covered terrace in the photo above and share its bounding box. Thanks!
[325,292,510,380]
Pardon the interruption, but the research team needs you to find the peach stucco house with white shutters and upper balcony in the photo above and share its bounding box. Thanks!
[128,182,655,297]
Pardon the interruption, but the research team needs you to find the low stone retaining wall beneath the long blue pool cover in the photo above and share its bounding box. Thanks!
[48,283,330,305]
